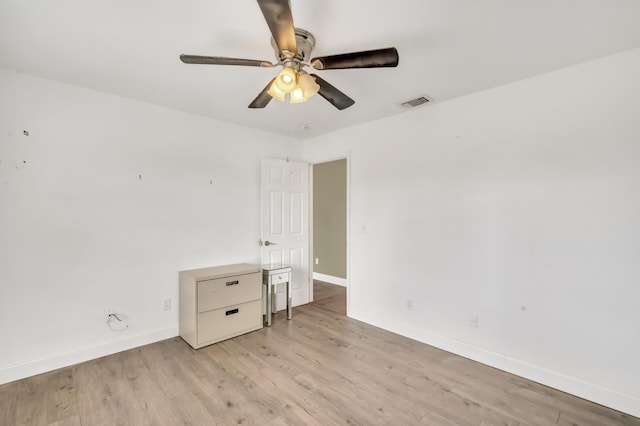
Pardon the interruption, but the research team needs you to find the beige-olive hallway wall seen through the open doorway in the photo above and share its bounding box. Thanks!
[313,160,347,279]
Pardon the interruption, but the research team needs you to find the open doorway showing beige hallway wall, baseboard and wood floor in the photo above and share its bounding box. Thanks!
[312,158,348,315]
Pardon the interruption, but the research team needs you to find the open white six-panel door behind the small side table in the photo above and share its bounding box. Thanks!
[261,158,311,310]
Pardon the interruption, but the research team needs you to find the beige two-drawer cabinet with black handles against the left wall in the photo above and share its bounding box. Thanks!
[179,263,262,349]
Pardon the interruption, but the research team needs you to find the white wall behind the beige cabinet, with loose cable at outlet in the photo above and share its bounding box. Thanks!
[0,70,301,383]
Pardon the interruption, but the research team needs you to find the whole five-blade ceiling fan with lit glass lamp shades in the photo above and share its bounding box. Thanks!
[180,0,399,110]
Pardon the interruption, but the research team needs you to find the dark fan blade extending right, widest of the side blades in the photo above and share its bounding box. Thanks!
[311,47,399,70]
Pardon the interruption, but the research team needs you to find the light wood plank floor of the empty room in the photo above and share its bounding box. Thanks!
[0,288,640,426]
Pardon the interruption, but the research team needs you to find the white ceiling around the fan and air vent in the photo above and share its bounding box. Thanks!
[0,0,640,138]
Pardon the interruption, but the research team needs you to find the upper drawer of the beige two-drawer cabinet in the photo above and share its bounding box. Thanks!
[198,273,262,313]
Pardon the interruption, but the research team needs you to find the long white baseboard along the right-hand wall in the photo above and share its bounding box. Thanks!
[348,309,640,417]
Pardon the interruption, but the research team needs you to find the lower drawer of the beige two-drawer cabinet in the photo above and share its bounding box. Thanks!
[198,300,262,345]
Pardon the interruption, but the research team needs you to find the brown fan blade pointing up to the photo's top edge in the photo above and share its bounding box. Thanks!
[258,0,298,58]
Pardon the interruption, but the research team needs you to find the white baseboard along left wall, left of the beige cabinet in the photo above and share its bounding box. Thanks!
[0,325,178,385]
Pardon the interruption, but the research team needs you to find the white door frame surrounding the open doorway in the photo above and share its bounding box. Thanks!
[309,150,351,316]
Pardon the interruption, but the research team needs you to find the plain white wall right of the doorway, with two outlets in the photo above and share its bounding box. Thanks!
[305,50,640,416]
